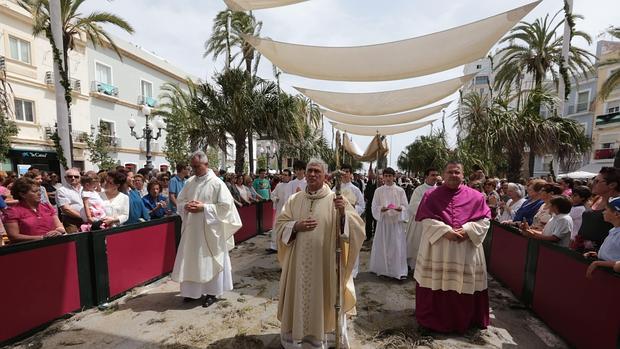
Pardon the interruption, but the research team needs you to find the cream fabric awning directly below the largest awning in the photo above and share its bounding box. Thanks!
[295,74,476,116]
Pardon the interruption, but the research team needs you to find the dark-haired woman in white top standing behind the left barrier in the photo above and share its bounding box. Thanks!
[102,170,129,227]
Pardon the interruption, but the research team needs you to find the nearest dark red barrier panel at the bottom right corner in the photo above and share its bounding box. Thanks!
[532,245,620,348]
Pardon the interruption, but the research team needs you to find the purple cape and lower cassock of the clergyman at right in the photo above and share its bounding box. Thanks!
[415,185,491,333]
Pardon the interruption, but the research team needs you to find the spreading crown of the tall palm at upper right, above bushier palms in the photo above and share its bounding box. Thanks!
[495,12,594,95]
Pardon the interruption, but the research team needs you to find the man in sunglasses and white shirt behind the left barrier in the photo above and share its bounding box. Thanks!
[56,168,84,233]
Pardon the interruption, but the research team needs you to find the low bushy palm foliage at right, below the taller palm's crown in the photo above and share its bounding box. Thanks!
[460,89,591,181]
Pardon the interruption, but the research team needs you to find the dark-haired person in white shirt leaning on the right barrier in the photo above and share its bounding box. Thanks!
[521,196,573,247]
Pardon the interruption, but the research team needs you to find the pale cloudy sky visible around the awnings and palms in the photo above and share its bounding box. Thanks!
[82,0,620,167]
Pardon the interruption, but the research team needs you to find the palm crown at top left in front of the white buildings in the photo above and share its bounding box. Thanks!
[17,0,134,74]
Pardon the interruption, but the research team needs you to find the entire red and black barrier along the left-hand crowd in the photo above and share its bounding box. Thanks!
[0,201,274,347]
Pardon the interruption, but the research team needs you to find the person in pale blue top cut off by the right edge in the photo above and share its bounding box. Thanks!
[584,197,620,278]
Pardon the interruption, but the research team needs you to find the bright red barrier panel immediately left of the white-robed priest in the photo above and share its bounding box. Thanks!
[106,221,177,297]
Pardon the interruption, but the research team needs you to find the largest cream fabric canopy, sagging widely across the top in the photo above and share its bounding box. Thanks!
[243,0,540,81]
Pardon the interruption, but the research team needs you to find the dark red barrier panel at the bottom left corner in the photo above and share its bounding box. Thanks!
[0,239,80,342]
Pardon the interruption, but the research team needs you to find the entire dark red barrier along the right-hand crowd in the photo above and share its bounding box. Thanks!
[484,222,620,348]
